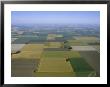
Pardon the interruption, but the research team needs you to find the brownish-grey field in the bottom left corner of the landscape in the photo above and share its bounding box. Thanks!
[11,58,39,77]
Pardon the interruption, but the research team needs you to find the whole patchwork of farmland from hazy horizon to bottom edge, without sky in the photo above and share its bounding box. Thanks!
[11,25,100,77]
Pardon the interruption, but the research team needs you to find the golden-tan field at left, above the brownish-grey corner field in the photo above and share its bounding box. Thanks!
[12,44,44,59]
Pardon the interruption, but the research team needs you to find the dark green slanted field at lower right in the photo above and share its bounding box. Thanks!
[70,58,96,77]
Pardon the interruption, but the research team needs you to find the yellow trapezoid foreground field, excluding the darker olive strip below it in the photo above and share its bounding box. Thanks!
[38,58,73,72]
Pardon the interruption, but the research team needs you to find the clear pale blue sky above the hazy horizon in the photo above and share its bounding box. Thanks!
[11,11,100,24]
